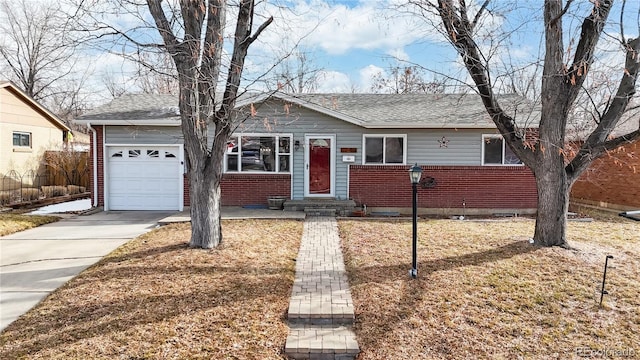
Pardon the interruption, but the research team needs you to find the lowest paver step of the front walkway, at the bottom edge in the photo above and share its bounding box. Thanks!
[285,325,360,360]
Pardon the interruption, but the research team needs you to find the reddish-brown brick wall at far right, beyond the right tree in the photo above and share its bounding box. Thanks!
[571,141,640,207]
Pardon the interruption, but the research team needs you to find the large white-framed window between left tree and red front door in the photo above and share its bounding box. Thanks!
[224,134,291,173]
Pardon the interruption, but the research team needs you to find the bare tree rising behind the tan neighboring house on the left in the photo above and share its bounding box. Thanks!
[0,0,89,125]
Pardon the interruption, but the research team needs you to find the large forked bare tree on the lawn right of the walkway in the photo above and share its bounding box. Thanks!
[411,0,640,246]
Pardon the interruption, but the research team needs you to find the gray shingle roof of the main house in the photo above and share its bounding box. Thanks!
[78,93,539,128]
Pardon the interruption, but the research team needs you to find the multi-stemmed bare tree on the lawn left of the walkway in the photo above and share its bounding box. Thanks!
[77,0,273,248]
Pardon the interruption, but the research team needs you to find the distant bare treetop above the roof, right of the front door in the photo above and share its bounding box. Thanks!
[371,65,445,94]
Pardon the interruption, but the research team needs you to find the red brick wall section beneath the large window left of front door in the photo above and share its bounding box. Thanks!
[220,174,291,206]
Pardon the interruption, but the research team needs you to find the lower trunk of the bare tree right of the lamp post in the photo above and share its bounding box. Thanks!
[533,156,571,247]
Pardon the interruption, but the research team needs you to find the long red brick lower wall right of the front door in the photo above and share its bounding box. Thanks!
[349,165,537,209]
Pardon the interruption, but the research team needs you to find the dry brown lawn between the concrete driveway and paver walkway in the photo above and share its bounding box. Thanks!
[0,220,302,359]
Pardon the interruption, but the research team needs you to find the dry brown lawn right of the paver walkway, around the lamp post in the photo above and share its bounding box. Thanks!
[339,219,640,360]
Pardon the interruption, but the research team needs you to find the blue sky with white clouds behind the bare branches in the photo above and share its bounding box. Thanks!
[0,0,640,108]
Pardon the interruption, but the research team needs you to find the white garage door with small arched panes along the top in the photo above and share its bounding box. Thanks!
[107,146,182,210]
